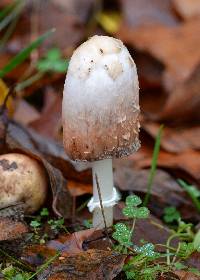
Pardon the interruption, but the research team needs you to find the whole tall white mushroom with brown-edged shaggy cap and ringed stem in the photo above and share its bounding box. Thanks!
[62,35,140,228]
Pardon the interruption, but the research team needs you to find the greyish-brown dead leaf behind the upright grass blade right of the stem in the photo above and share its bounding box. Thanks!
[114,166,191,208]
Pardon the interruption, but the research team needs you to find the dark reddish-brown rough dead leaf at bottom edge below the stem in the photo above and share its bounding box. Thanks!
[38,249,125,280]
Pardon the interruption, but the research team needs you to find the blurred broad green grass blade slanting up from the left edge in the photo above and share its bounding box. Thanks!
[0,29,55,78]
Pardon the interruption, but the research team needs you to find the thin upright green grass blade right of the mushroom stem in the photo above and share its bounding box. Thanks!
[143,125,164,206]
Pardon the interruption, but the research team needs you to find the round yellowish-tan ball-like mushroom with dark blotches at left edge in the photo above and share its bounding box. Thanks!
[0,153,47,213]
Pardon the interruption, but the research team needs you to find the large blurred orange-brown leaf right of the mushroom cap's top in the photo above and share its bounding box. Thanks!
[118,19,200,92]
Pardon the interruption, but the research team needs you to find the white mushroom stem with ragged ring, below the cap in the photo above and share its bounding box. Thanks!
[88,159,118,228]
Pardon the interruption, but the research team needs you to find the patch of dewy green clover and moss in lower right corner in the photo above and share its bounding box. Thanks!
[112,195,200,280]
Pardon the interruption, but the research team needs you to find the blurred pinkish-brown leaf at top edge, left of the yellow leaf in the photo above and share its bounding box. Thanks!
[37,0,93,49]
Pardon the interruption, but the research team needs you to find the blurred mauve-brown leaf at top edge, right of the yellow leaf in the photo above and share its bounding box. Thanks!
[120,0,178,26]
